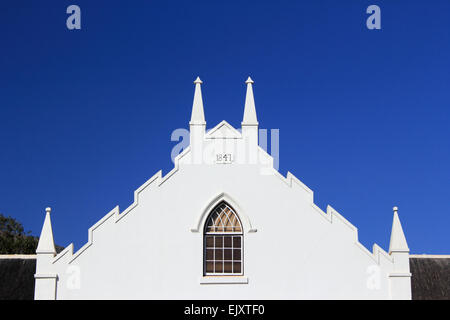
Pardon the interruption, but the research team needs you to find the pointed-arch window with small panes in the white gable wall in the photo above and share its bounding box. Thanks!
[204,202,243,275]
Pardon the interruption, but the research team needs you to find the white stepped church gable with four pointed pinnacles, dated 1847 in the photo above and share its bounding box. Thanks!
[35,78,411,299]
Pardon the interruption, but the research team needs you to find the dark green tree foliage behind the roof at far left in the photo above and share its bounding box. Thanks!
[0,213,39,254]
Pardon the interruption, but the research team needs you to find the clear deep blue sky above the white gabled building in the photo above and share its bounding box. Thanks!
[0,0,450,254]
